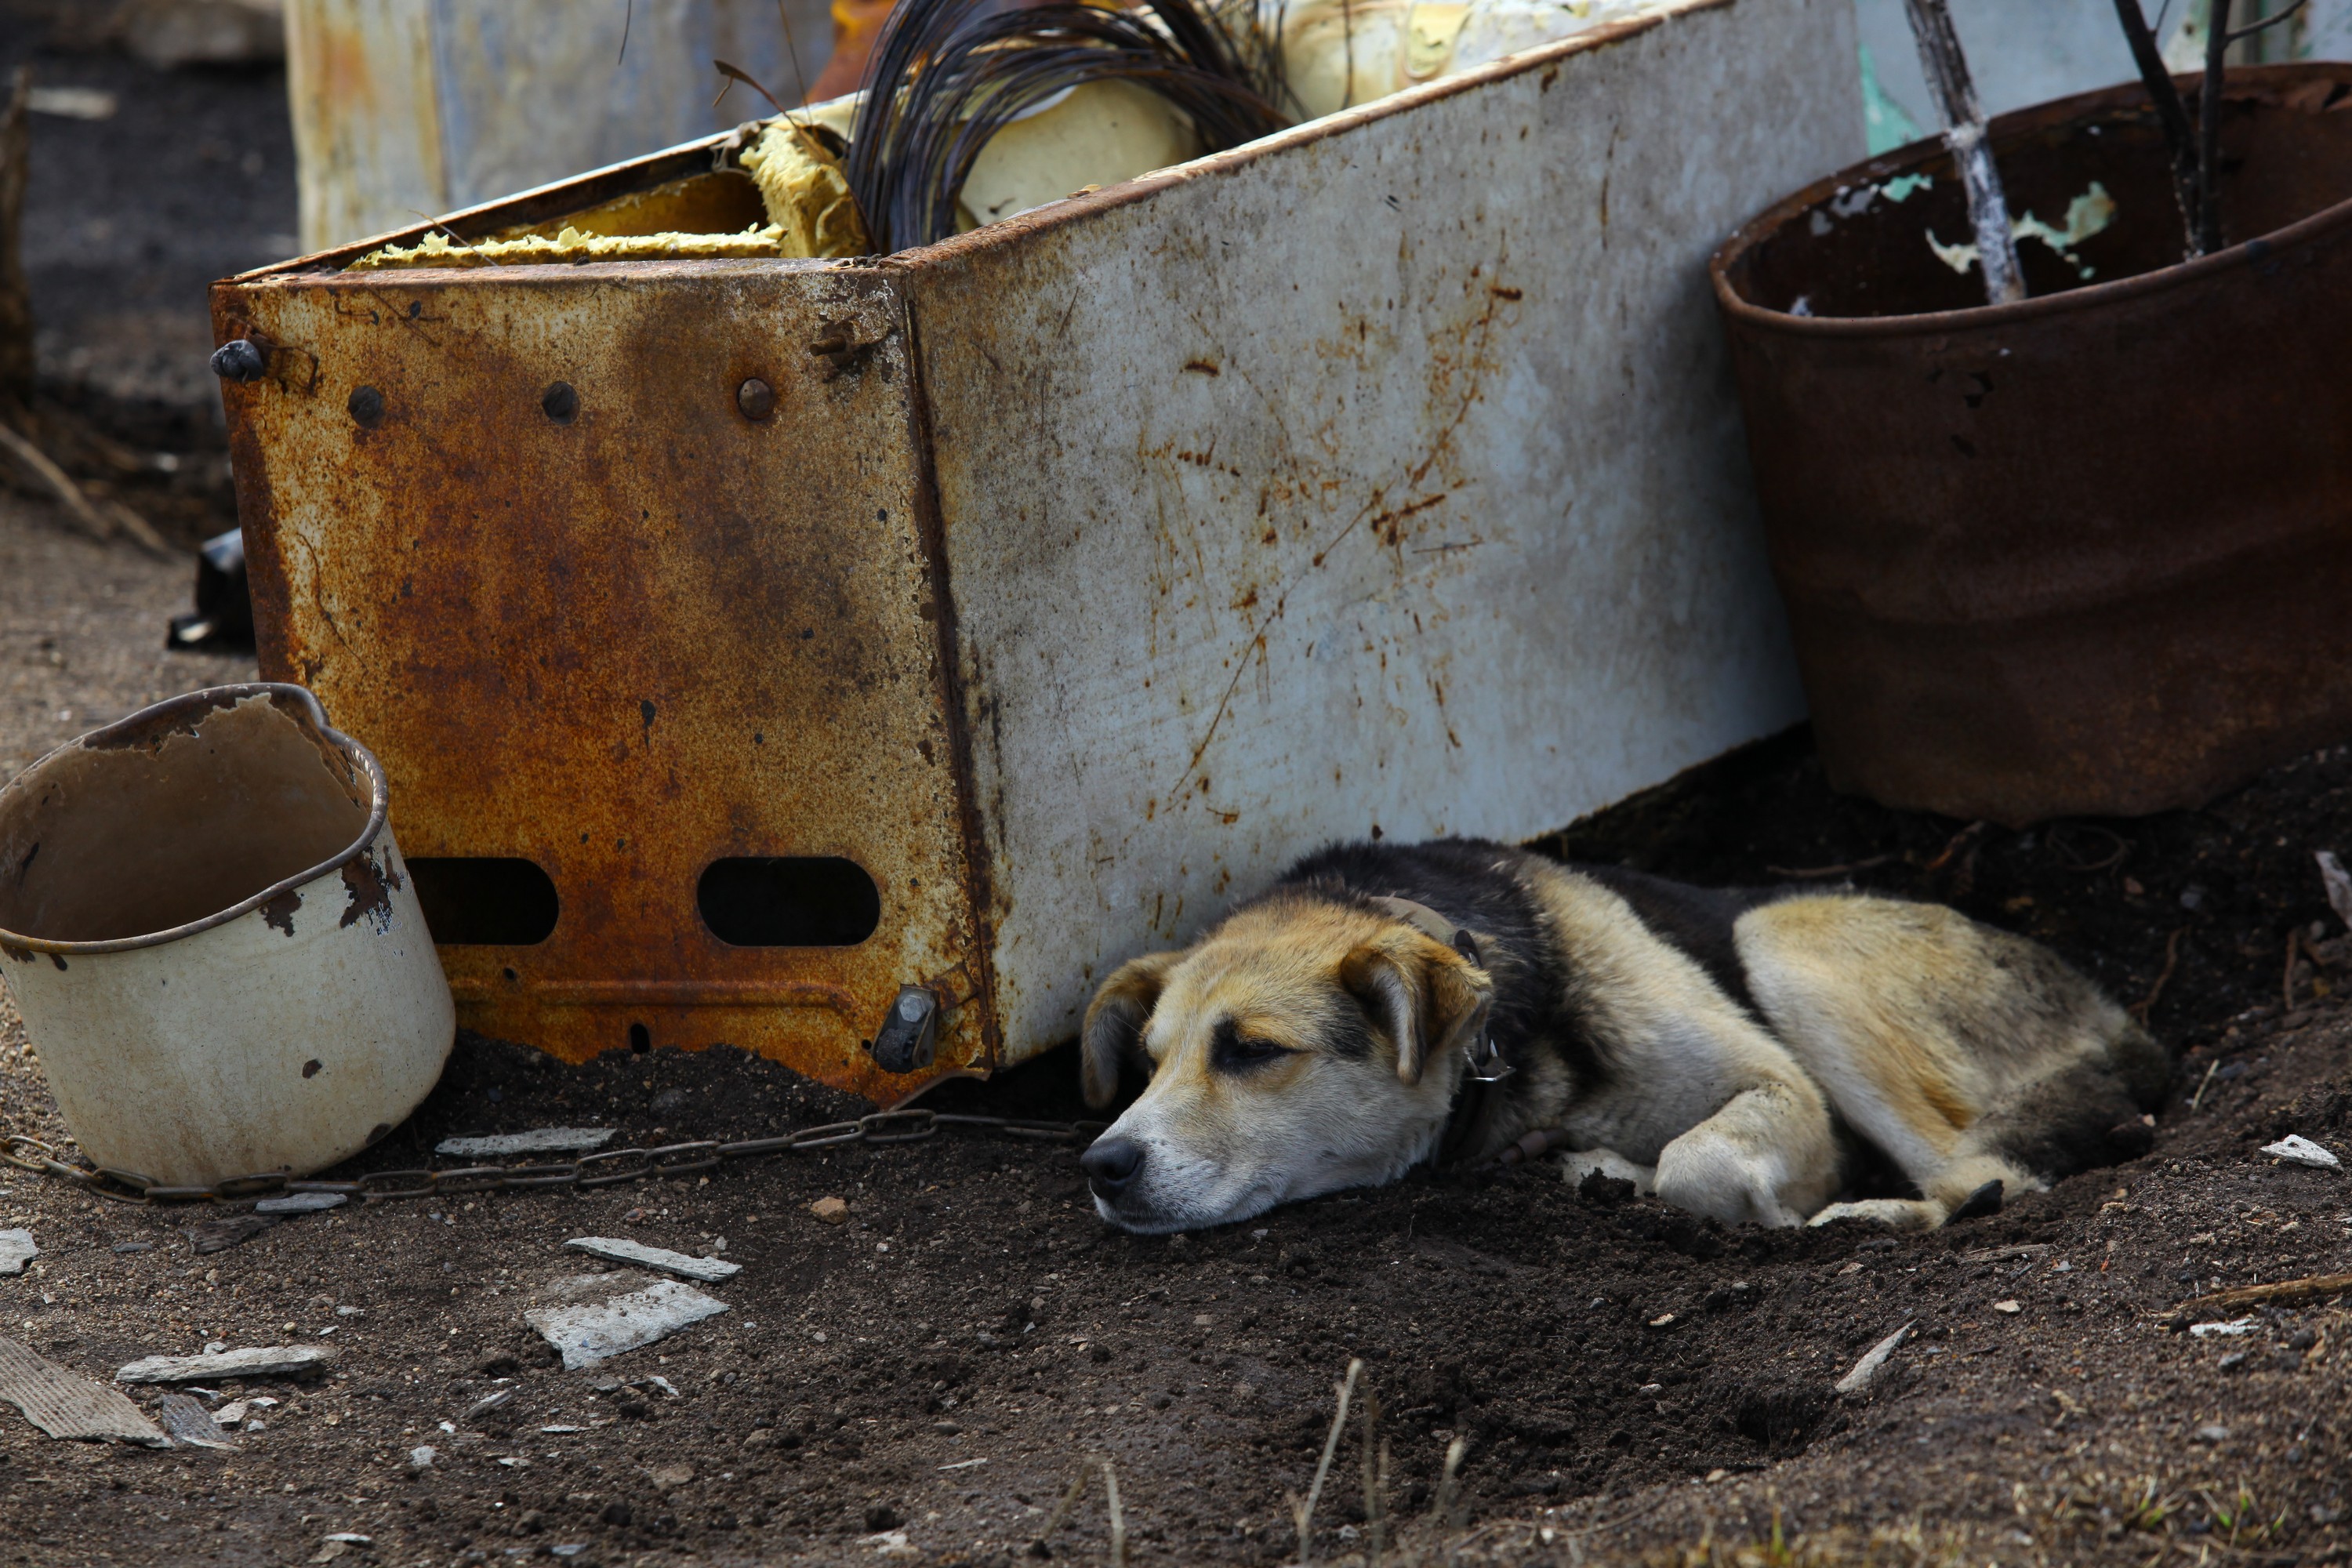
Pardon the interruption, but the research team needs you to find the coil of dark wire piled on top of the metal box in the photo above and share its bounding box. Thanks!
[847,0,1289,254]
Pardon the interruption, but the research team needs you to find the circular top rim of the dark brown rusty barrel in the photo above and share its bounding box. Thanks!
[1708,61,2352,339]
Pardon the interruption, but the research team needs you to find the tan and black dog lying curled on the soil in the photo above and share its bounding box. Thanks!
[1082,839,2171,1232]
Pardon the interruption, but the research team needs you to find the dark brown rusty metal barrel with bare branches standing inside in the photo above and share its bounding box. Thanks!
[1712,64,2352,825]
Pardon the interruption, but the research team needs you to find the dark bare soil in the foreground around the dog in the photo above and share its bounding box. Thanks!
[0,592,2352,1563]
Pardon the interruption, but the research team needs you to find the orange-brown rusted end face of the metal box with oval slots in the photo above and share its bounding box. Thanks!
[216,263,988,1098]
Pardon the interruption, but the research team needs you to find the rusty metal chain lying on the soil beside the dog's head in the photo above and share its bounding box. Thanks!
[0,1109,1110,1203]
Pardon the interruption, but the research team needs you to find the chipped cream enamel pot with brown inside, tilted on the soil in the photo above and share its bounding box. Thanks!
[0,684,456,1187]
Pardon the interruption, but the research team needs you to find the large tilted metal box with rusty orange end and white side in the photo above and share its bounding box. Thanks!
[214,0,1860,1100]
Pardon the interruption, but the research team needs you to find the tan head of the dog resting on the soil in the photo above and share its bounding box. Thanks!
[1082,891,1494,1232]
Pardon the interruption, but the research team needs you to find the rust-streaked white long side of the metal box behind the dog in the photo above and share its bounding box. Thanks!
[903,0,1863,1060]
